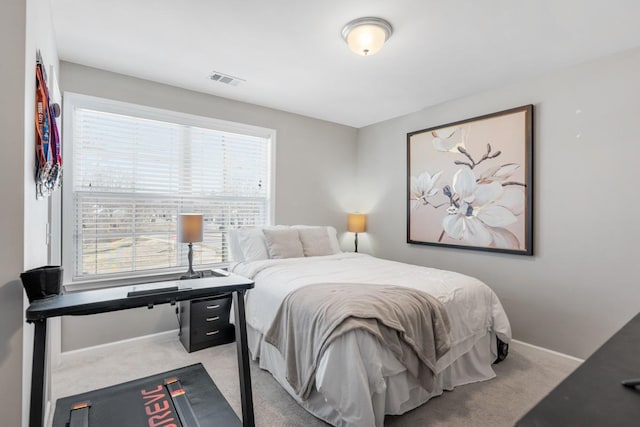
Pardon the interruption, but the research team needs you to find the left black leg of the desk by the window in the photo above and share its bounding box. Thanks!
[29,319,47,427]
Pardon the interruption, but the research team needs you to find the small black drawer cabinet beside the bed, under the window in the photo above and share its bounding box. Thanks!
[179,293,236,353]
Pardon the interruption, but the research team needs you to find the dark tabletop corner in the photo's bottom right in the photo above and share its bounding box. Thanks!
[517,314,640,427]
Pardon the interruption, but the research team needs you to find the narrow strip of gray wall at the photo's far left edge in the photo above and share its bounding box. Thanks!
[0,0,26,426]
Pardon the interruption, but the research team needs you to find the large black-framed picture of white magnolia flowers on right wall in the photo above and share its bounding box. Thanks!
[407,105,533,255]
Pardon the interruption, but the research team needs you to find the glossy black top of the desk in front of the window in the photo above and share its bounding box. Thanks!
[26,274,253,322]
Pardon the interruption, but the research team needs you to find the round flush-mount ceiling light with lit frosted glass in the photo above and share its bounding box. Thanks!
[342,17,393,56]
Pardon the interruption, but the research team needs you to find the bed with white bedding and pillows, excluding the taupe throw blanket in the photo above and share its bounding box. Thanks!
[230,226,511,426]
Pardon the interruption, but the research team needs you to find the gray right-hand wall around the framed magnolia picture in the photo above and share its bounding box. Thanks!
[358,49,640,357]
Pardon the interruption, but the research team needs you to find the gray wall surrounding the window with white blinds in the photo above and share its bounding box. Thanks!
[60,62,357,351]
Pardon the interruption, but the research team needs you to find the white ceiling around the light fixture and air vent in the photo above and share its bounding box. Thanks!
[51,0,640,127]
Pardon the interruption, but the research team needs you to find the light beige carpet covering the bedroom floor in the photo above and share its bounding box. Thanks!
[51,336,578,427]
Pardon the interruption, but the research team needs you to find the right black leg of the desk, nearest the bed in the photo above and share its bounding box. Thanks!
[233,290,255,427]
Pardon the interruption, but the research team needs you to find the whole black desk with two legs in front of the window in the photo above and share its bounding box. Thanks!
[26,274,255,427]
